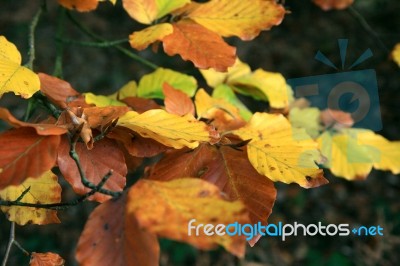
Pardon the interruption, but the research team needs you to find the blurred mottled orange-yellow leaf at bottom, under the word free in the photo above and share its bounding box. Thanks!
[126,178,249,257]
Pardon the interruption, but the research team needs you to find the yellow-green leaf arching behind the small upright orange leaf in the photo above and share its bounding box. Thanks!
[137,68,197,99]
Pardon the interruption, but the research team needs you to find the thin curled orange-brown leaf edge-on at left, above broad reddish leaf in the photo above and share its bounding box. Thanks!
[0,107,68,136]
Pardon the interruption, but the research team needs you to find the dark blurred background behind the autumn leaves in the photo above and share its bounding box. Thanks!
[0,0,400,265]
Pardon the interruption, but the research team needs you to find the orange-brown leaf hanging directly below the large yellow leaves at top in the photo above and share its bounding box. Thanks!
[163,20,236,72]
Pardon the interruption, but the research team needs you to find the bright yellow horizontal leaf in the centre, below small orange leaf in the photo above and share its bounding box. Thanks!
[117,109,211,149]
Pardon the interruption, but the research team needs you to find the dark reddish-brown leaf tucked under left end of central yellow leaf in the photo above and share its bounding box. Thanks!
[107,127,168,157]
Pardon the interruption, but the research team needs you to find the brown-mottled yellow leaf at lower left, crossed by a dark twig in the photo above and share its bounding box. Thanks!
[0,171,61,225]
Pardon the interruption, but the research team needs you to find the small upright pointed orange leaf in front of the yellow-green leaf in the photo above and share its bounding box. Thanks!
[163,82,194,116]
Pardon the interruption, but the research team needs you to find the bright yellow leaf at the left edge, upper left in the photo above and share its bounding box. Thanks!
[0,36,40,98]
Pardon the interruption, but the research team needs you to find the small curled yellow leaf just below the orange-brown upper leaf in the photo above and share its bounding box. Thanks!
[200,58,251,88]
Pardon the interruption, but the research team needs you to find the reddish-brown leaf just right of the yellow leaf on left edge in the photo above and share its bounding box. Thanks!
[38,72,80,108]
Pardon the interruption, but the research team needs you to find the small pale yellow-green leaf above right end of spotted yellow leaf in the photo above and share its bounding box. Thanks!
[289,107,322,139]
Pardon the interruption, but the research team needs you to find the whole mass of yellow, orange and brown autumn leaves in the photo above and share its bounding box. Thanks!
[0,0,400,265]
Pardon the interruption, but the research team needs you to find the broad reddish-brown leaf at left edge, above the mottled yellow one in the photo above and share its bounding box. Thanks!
[0,127,60,189]
